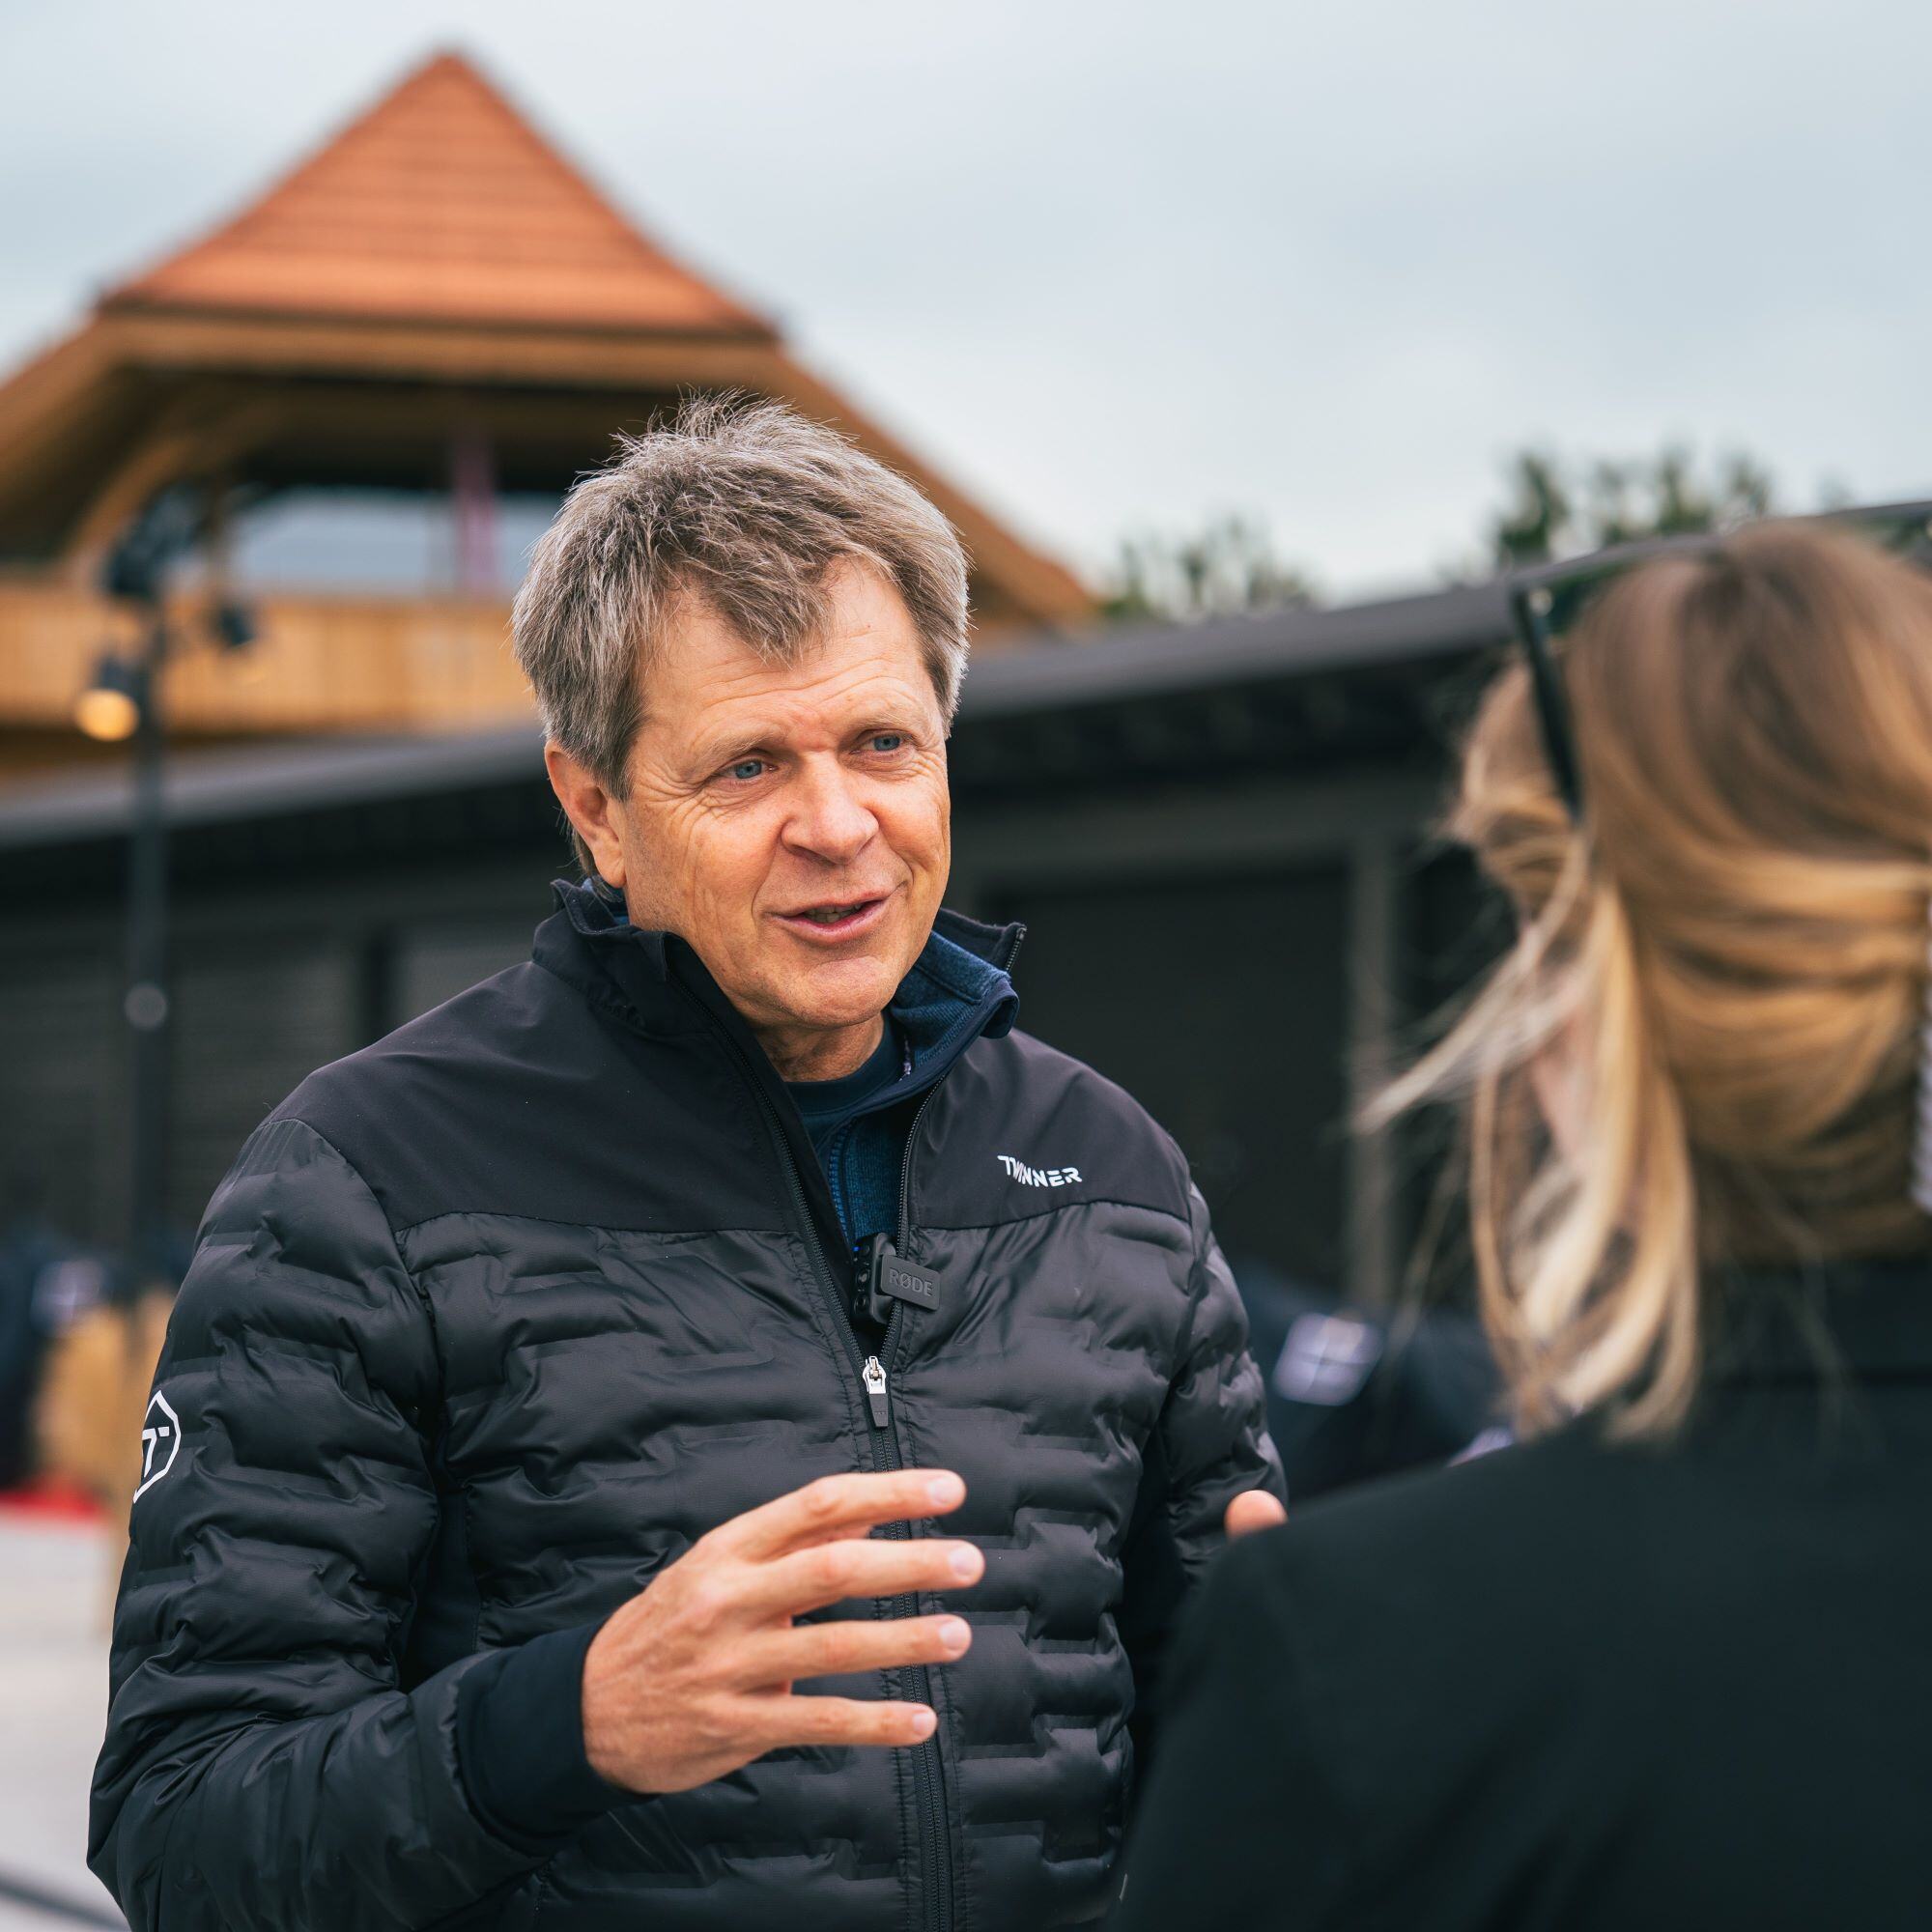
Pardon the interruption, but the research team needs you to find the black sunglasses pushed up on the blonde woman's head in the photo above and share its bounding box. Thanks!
[1507,502,1932,827]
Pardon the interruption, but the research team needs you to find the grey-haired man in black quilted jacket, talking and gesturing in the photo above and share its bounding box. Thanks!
[93,406,1281,1932]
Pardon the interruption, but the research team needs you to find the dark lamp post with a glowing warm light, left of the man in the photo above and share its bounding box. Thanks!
[75,489,255,1281]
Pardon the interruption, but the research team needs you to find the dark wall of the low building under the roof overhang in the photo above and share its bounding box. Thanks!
[0,730,1493,1294]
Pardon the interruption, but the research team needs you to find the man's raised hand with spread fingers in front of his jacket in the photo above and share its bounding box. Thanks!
[583,1468,985,1791]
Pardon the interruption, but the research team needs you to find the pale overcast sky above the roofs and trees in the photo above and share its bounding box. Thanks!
[0,0,1932,593]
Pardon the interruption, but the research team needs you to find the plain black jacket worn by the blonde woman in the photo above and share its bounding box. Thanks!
[1117,1264,1932,1932]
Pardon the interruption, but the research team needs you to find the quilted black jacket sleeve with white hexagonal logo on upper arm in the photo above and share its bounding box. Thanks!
[89,1119,535,1932]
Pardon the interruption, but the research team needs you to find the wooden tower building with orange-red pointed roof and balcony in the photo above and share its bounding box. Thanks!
[0,52,1090,773]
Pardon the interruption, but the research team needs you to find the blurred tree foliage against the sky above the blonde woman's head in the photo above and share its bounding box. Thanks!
[1488,444,1772,568]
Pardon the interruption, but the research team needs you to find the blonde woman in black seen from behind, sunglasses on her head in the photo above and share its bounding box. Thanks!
[1121,524,1932,1932]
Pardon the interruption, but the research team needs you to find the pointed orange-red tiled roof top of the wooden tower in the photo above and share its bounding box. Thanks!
[106,54,771,336]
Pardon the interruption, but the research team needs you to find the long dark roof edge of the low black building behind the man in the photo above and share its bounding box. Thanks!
[0,583,1507,885]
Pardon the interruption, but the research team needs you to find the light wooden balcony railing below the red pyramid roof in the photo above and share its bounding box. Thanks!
[0,574,531,734]
